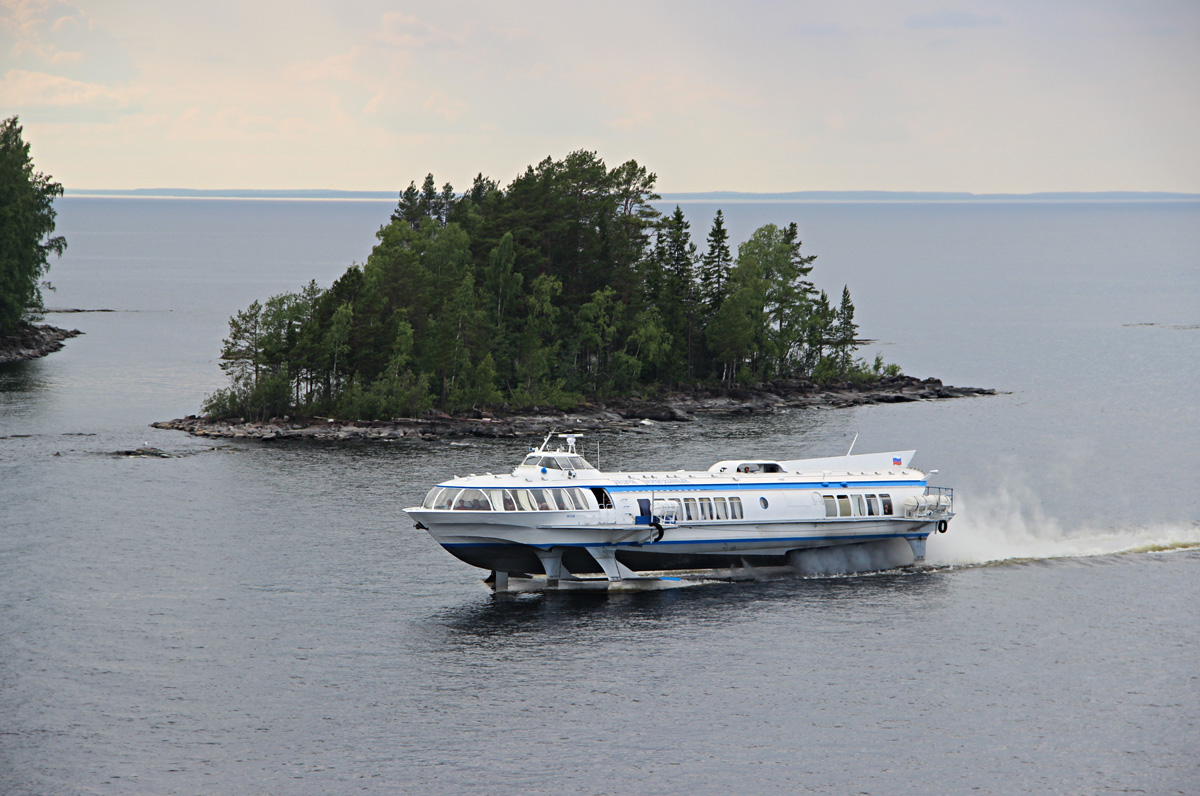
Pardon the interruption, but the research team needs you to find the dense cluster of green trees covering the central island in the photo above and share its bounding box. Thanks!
[205,151,896,420]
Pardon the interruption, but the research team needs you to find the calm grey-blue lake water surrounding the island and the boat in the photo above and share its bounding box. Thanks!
[0,197,1200,796]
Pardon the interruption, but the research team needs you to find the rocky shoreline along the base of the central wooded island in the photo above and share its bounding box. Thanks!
[151,376,996,441]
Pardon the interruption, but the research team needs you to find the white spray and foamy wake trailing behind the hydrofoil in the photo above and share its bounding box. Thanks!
[925,491,1200,567]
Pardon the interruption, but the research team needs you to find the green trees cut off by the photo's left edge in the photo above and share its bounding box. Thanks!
[0,116,67,336]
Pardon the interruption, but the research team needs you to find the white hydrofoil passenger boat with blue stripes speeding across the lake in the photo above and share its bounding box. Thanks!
[404,435,953,591]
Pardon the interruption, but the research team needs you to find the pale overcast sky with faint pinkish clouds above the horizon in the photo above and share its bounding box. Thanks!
[0,0,1200,192]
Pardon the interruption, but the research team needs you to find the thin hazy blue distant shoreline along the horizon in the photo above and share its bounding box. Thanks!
[65,188,1200,204]
